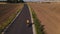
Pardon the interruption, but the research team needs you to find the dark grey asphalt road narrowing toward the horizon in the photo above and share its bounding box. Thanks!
[4,4,33,34]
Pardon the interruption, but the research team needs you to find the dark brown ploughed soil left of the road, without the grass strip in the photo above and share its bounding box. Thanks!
[0,4,23,25]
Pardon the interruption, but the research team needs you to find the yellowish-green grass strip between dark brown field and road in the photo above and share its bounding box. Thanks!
[0,4,22,34]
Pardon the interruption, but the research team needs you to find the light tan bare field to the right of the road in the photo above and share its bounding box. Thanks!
[29,3,60,34]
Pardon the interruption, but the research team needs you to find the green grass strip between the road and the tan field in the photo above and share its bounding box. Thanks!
[28,5,45,34]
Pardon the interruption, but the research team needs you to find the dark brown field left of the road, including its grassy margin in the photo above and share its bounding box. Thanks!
[0,3,23,32]
